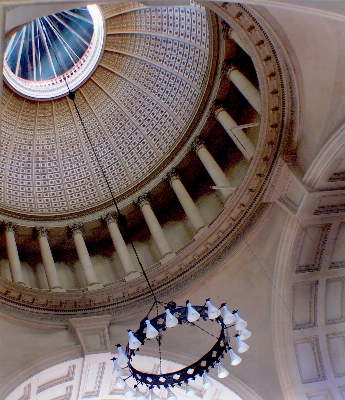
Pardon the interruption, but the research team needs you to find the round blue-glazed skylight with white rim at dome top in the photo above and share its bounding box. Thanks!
[4,5,104,99]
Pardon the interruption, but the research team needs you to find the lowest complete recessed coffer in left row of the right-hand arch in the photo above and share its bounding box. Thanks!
[294,336,327,384]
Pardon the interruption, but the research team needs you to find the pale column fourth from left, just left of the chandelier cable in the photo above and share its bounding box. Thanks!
[104,213,137,275]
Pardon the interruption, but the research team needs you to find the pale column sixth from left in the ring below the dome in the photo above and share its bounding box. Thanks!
[166,169,206,232]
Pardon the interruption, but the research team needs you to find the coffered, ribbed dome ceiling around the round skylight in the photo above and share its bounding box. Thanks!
[0,2,215,220]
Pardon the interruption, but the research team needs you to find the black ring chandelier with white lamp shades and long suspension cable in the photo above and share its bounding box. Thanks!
[64,65,251,400]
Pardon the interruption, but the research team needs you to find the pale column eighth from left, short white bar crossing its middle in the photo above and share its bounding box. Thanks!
[212,104,255,161]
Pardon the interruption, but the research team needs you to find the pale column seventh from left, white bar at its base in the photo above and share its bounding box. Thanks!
[192,138,233,199]
